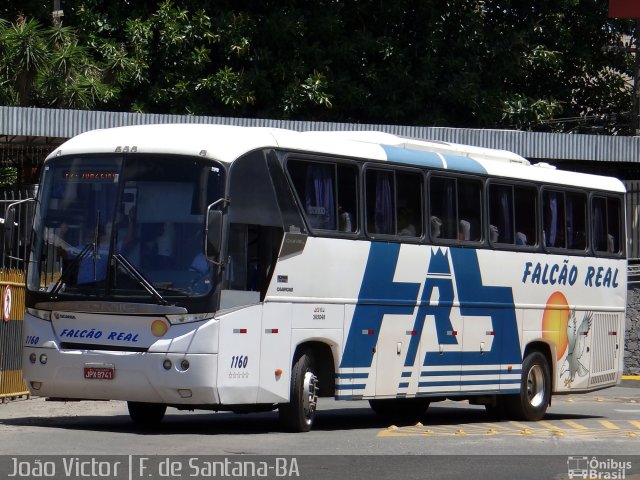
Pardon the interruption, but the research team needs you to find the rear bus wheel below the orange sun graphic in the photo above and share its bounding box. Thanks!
[505,351,551,421]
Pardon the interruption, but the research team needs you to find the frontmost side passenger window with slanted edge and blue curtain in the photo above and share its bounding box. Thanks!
[287,160,358,232]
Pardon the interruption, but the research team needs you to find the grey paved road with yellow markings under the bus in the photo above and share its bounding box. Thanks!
[0,382,640,478]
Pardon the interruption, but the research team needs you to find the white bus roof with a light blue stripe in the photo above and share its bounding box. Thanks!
[47,123,625,192]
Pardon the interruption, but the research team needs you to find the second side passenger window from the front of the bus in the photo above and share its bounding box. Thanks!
[366,169,423,237]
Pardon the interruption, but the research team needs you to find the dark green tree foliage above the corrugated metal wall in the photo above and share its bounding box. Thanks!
[0,0,633,134]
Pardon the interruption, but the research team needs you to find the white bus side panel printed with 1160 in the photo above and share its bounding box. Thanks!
[218,305,263,405]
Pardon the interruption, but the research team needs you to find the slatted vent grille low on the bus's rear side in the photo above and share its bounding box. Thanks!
[590,313,619,385]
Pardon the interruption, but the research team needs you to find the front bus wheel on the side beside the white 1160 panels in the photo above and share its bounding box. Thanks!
[278,350,318,432]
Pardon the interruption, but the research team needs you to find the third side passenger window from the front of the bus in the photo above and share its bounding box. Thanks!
[429,175,482,242]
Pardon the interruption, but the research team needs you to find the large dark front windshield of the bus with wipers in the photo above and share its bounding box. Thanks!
[27,155,224,304]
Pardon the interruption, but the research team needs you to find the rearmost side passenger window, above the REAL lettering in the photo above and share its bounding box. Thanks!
[591,197,622,253]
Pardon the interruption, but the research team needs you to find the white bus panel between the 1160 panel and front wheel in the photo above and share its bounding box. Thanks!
[256,303,293,403]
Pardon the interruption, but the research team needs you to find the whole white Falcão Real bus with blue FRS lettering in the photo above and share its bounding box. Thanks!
[17,124,626,431]
